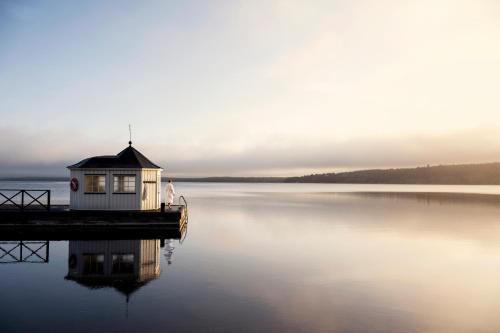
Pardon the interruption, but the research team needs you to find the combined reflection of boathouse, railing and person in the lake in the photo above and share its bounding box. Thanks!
[0,225,187,303]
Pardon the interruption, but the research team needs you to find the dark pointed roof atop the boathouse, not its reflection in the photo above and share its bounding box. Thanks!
[68,145,161,169]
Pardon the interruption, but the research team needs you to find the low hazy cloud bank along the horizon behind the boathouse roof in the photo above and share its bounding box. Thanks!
[0,129,500,176]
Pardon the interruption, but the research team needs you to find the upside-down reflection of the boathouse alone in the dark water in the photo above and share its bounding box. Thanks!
[66,240,161,300]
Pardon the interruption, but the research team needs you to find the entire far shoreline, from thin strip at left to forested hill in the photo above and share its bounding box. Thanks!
[0,162,500,185]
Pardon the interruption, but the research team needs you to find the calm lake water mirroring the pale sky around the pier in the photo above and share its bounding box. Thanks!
[0,182,500,333]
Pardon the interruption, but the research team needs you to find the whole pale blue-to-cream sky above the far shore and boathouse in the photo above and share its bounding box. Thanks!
[0,0,500,176]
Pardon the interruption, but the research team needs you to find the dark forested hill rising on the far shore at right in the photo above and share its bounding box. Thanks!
[285,163,500,185]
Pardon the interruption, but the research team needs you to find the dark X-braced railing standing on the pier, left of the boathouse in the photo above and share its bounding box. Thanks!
[0,189,50,210]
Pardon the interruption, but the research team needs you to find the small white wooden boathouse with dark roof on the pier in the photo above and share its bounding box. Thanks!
[68,142,163,210]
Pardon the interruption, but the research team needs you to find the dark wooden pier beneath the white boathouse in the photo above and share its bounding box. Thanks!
[0,190,188,239]
